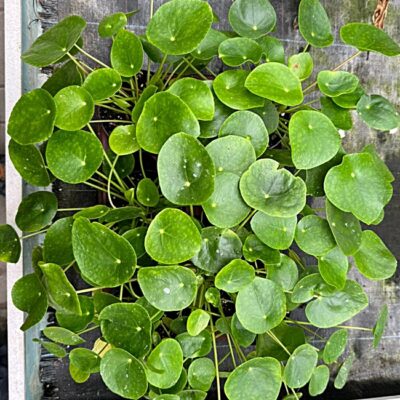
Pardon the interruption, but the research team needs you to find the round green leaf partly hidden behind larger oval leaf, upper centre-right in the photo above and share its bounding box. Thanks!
[213,70,264,110]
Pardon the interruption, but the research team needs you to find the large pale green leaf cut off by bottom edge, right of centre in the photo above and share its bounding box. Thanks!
[224,357,282,400]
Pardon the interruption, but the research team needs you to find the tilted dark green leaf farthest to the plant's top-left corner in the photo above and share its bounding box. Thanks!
[21,15,86,67]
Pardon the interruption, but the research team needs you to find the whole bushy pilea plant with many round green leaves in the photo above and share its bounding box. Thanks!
[0,0,400,400]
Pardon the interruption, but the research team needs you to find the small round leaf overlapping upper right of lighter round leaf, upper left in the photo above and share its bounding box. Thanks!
[83,68,122,101]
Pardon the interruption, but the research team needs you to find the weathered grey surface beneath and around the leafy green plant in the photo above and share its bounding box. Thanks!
[37,0,400,400]
